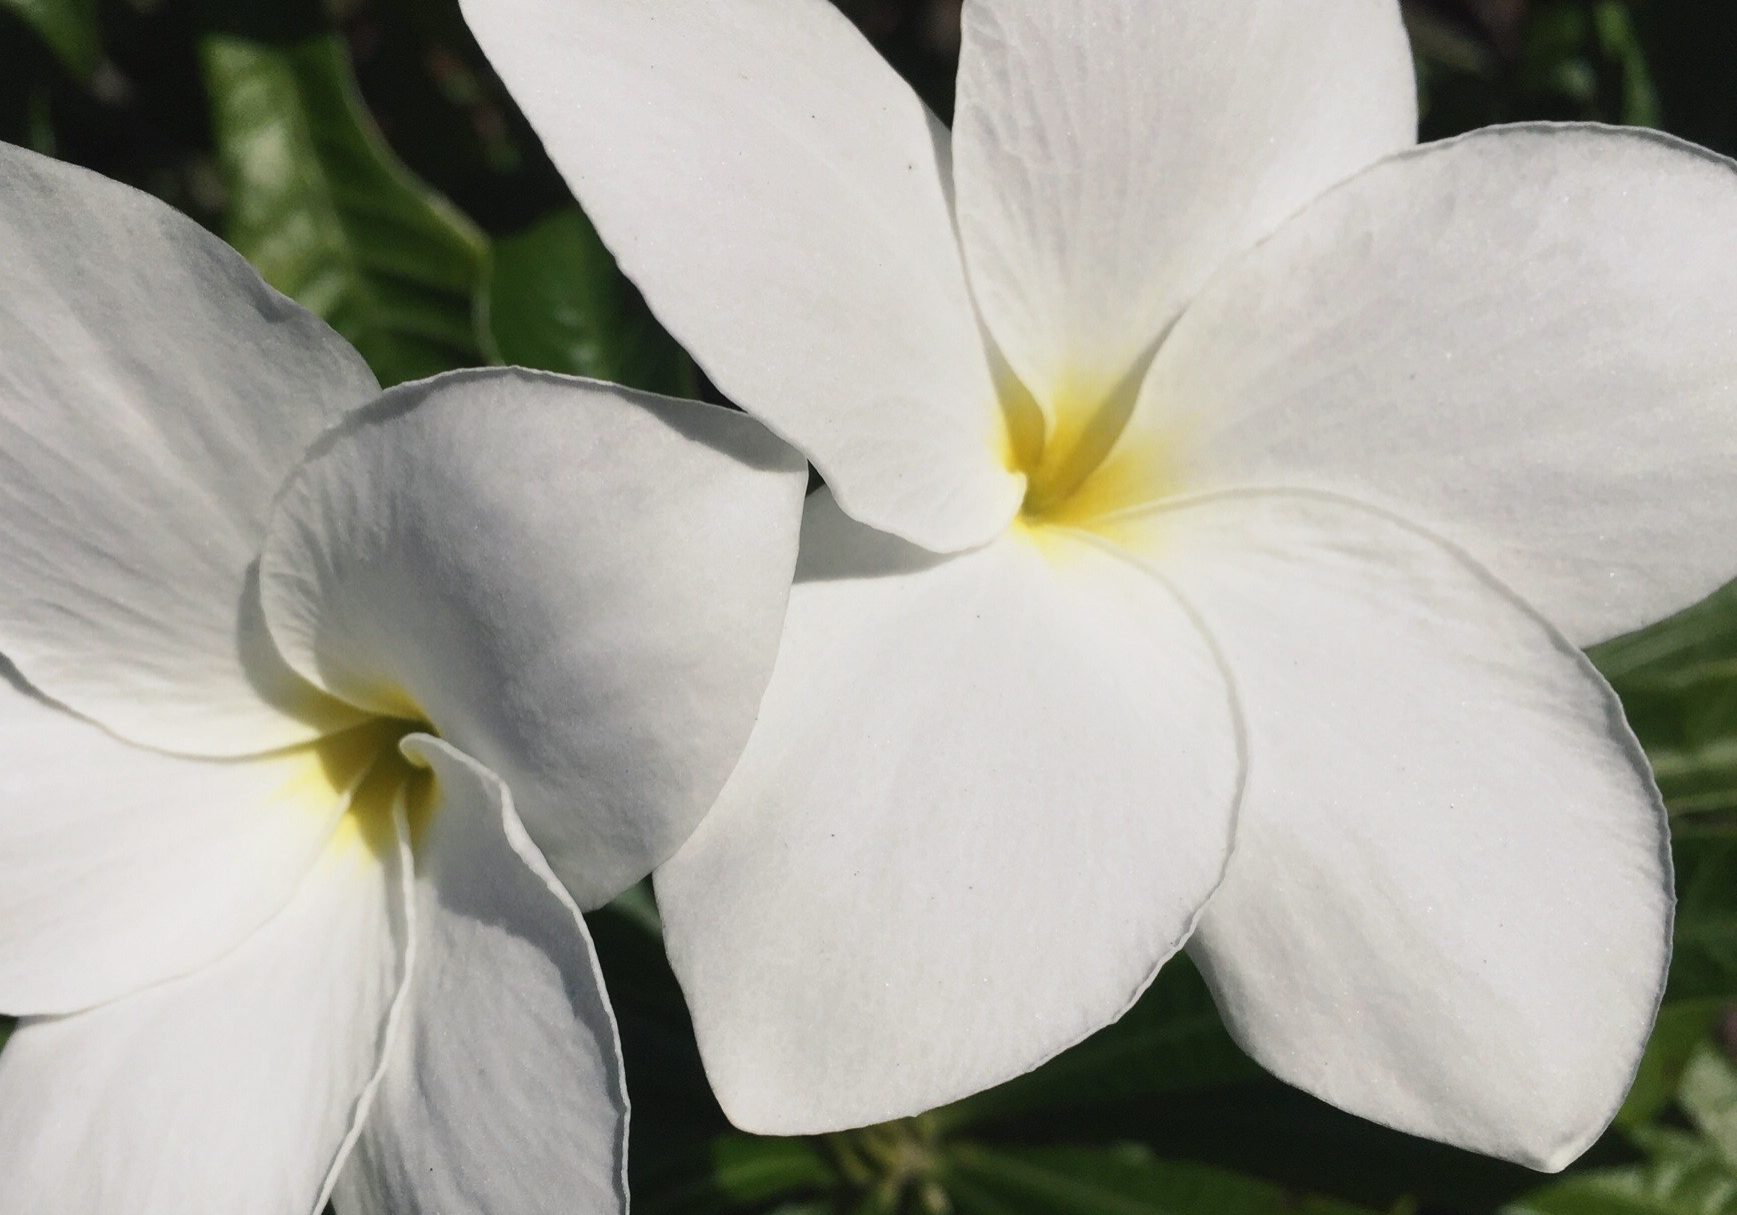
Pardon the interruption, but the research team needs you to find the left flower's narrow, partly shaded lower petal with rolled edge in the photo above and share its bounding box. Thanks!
[335,737,627,1215]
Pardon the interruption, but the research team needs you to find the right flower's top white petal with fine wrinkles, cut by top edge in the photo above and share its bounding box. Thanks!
[954,0,1417,405]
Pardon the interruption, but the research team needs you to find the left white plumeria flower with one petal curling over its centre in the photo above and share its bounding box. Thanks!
[0,146,806,1215]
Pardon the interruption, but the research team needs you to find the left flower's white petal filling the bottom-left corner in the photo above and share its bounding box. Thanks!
[0,823,408,1215]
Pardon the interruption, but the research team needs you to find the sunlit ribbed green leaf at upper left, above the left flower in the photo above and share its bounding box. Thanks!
[200,35,485,386]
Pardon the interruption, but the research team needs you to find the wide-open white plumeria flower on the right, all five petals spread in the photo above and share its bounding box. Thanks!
[466,0,1737,1168]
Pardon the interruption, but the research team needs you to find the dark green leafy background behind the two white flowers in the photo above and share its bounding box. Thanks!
[10,0,1737,1215]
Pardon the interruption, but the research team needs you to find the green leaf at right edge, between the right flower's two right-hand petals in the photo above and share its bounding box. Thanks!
[1593,584,1737,817]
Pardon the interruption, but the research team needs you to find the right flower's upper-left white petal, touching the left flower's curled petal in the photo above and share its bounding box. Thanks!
[464,0,1021,549]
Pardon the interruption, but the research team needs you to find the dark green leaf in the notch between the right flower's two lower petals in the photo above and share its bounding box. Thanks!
[935,956,1263,1130]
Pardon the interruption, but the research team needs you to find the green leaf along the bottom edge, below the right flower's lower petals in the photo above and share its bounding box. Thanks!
[941,1147,1358,1215]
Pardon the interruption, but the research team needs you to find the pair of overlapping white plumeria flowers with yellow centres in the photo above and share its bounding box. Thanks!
[0,0,1737,1215]
